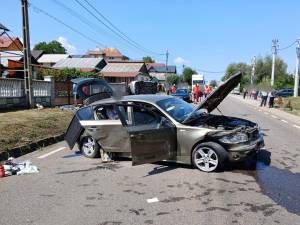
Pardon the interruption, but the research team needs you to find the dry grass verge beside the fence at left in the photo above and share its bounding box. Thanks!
[0,109,73,152]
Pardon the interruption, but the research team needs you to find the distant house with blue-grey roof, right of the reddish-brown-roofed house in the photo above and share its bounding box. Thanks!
[147,63,177,86]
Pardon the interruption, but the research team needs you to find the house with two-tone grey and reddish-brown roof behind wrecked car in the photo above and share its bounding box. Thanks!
[99,61,150,84]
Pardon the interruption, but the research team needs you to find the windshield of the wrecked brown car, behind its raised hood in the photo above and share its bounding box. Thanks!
[157,98,195,122]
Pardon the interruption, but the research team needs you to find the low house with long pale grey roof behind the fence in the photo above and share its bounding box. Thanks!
[53,58,106,72]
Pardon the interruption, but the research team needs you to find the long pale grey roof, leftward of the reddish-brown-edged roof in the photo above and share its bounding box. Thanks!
[53,58,103,69]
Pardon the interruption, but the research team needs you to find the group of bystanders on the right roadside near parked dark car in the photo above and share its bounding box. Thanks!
[243,89,276,108]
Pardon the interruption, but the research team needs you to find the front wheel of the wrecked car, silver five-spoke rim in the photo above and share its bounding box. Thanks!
[192,142,228,172]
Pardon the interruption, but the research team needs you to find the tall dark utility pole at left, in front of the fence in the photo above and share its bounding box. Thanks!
[21,0,34,108]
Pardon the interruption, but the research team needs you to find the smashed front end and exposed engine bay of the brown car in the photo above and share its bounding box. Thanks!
[190,114,264,162]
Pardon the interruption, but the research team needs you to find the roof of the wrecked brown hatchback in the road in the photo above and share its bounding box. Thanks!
[91,94,173,105]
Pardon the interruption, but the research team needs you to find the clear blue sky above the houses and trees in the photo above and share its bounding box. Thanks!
[0,0,300,80]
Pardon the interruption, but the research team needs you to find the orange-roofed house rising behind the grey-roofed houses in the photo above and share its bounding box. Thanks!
[84,48,129,61]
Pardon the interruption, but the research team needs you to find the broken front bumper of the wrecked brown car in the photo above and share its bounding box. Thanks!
[227,134,265,162]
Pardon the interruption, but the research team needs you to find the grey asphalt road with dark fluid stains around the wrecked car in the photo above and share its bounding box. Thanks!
[0,97,300,225]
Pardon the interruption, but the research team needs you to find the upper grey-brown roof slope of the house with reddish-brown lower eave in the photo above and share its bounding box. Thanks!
[101,61,144,73]
